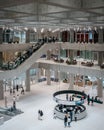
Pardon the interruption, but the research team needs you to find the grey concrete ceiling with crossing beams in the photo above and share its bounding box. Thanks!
[0,0,104,28]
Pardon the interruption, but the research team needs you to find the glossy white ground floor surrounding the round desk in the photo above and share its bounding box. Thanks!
[0,82,104,130]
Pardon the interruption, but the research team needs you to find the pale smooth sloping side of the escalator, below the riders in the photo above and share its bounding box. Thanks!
[0,44,59,80]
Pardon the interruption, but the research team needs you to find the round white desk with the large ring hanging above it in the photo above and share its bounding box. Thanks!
[53,90,87,120]
